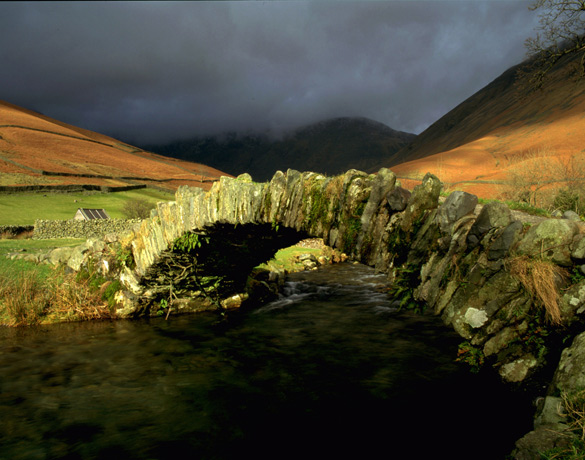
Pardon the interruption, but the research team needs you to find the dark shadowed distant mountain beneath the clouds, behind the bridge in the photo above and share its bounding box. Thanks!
[144,118,415,181]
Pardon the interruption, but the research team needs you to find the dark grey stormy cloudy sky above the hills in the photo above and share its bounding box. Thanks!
[0,0,538,145]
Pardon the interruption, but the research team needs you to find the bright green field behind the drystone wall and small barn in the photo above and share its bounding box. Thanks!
[0,188,175,225]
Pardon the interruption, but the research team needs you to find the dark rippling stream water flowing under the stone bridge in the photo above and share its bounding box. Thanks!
[0,264,532,460]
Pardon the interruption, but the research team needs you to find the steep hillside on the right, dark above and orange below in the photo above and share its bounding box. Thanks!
[372,52,585,197]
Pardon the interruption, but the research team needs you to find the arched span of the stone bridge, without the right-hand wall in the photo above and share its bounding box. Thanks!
[114,169,410,314]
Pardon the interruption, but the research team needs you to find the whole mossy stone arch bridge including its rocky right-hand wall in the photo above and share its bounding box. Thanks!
[106,168,585,390]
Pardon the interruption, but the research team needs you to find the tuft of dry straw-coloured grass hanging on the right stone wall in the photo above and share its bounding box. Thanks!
[509,256,568,325]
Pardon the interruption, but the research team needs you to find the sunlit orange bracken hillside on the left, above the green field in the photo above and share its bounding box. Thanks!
[0,101,228,190]
